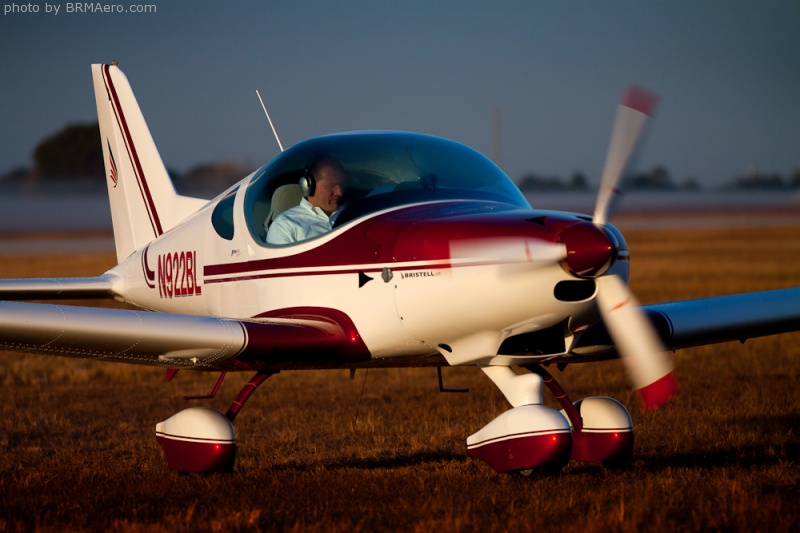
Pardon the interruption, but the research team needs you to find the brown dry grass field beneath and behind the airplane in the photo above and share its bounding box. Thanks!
[0,222,800,531]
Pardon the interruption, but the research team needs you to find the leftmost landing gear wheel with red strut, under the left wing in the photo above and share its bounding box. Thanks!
[156,372,275,473]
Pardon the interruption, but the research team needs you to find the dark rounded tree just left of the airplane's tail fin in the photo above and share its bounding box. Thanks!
[33,122,105,178]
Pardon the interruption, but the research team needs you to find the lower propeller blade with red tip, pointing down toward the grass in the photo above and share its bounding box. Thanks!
[596,276,677,410]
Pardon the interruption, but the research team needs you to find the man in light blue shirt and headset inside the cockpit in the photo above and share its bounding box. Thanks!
[267,155,346,244]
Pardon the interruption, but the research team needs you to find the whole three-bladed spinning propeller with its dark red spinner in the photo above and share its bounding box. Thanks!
[450,86,677,410]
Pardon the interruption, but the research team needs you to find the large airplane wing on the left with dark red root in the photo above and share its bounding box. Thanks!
[0,300,369,371]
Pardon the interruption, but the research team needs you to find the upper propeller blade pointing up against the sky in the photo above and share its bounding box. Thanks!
[593,85,659,226]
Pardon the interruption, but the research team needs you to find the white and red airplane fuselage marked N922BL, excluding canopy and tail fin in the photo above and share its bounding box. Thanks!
[111,187,627,365]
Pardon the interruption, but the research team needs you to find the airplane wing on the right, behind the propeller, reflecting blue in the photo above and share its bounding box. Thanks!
[568,288,800,362]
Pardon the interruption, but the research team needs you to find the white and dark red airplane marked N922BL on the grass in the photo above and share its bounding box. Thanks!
[0,65,800,472]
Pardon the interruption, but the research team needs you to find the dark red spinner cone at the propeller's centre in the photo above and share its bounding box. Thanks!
[558,222,617,278]
